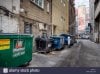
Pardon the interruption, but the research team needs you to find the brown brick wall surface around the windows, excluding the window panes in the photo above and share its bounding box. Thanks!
[20,0,51,35]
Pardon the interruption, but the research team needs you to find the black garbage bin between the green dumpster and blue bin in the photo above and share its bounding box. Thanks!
[35,34,52,53]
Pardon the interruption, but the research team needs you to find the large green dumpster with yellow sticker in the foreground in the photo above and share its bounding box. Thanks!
[0,34,33,67]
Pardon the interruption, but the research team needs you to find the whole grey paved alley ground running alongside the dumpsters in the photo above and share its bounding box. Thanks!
[28,39,100,67]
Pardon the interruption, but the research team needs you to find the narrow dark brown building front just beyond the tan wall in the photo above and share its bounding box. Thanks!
[69,0,76,35]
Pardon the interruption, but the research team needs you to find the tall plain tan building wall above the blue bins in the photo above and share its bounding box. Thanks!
[52,0,69,35]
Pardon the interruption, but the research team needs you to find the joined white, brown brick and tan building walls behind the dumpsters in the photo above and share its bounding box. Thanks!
[0,0,70,37]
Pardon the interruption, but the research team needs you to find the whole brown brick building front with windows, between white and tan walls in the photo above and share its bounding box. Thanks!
[20,0,52,36]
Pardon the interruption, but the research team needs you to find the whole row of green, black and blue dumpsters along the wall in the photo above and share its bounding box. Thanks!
[0,33,76,67]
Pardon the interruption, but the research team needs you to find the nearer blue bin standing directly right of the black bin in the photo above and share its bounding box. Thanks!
[51,36,64,50]
